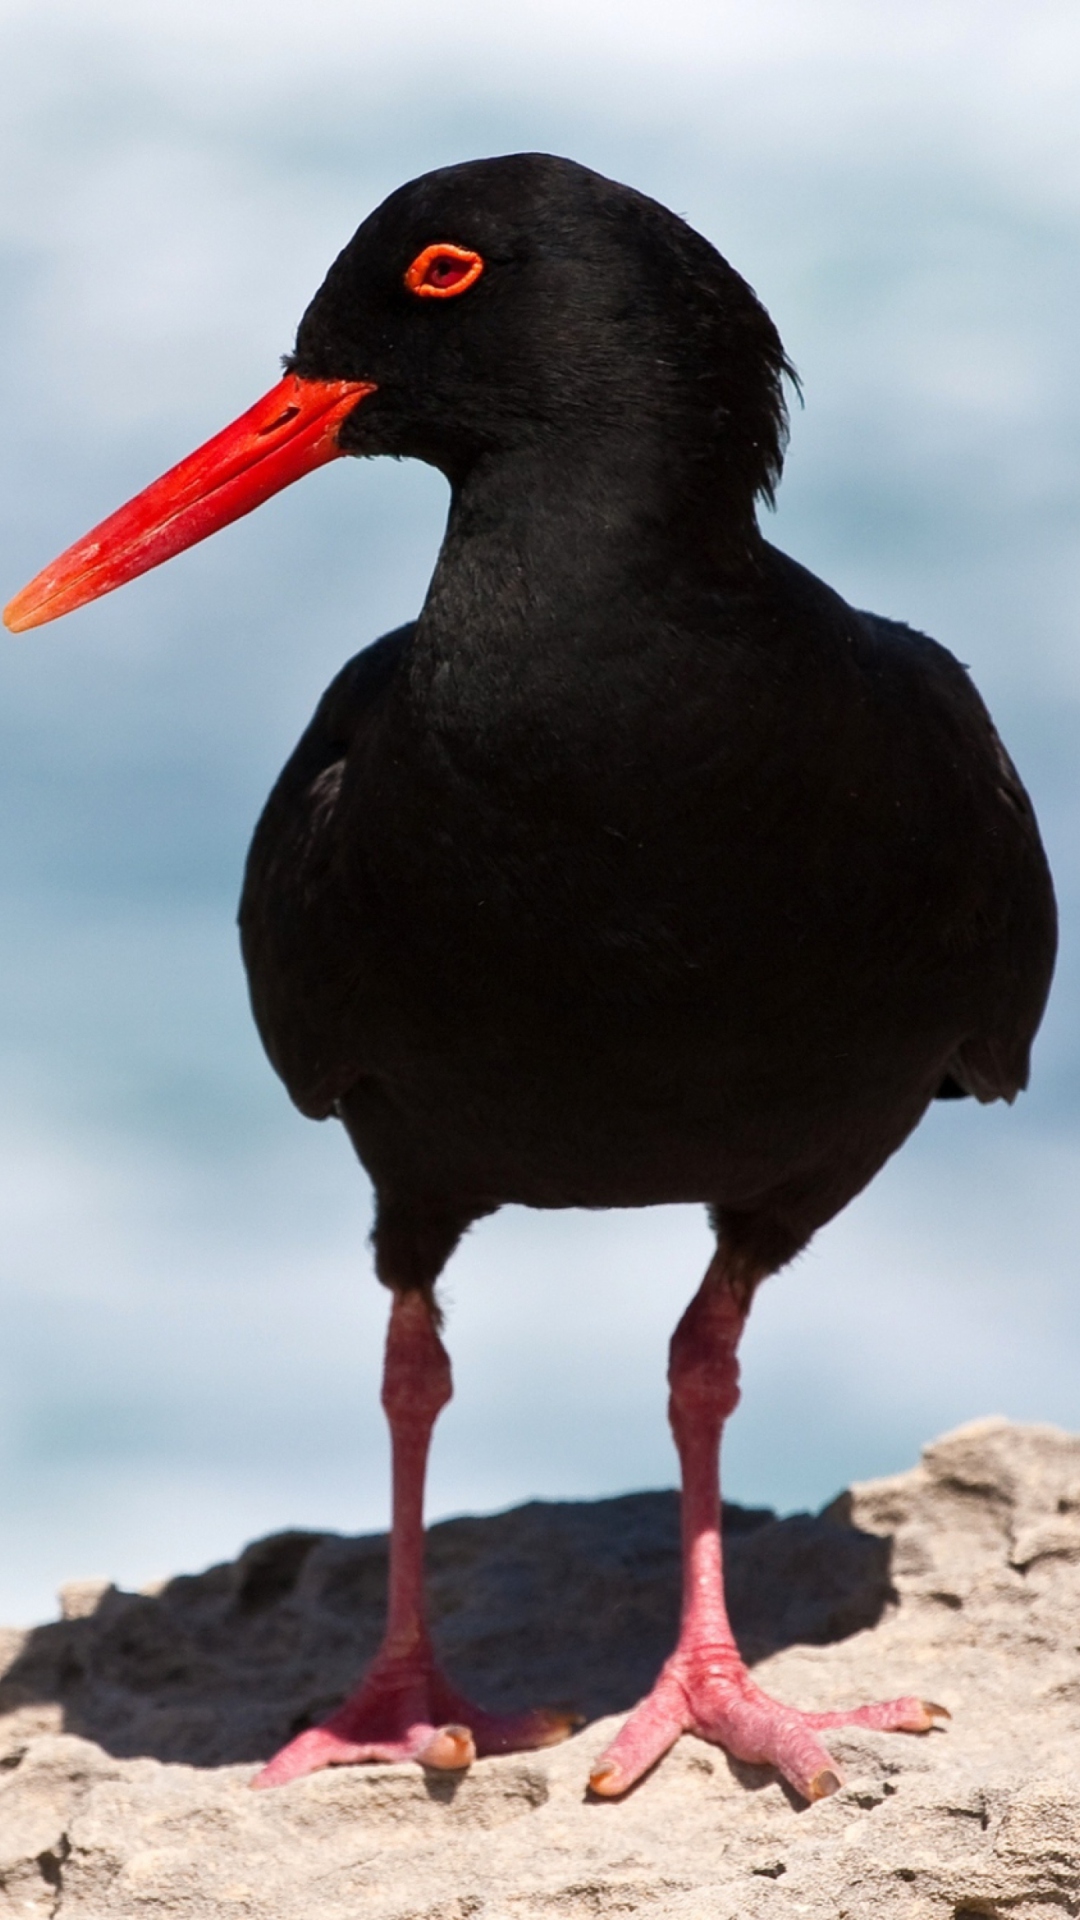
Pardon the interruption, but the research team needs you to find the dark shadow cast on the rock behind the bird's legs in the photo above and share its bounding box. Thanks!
[0,1494,894,1766]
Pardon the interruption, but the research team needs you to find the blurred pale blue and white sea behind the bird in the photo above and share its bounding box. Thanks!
[0,0,1080,1620]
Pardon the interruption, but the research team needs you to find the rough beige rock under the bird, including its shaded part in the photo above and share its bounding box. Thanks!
[0,1421,1080,1920]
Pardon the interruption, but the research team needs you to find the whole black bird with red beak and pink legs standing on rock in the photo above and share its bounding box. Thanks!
[8,154,1055,1799]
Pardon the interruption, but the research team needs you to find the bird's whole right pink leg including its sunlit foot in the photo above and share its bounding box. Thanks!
[590,1254,947,1801]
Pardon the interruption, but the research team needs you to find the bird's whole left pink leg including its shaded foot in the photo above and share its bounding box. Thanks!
[252,1292,577,1788]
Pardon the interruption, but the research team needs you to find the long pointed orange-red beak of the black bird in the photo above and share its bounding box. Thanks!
[4,372,375,634]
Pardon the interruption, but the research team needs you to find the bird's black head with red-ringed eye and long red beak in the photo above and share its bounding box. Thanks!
[4,154,790,632]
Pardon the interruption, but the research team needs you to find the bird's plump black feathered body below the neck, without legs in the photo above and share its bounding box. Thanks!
[242,541,1053,1284]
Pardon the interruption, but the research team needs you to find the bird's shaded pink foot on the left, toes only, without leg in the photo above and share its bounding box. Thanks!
[252,1647,580,1788]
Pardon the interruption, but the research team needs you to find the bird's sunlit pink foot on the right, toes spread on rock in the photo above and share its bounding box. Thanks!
[590,1645,949,1801]
